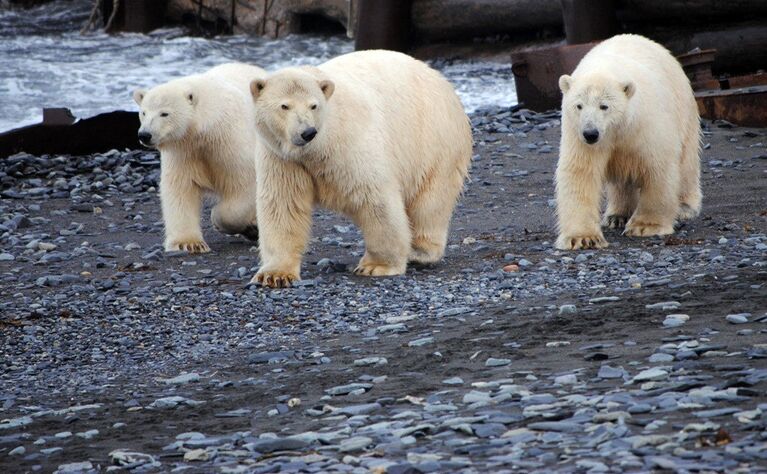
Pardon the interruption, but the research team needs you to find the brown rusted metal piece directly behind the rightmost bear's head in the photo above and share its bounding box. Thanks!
[511,42,597,111]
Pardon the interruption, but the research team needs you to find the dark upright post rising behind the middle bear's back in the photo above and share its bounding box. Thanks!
[354,0,412,51]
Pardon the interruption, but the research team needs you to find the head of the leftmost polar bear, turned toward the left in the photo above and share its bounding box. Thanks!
[133,82,198,148]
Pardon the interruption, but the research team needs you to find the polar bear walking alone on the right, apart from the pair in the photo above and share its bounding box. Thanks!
[556,35,701,250]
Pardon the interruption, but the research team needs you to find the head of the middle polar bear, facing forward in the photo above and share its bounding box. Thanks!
[250,68,335,159]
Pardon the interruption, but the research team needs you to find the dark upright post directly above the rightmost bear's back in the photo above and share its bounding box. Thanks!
[562,0,618,44]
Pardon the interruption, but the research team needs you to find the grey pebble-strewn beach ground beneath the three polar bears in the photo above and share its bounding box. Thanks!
[0,110,767,473]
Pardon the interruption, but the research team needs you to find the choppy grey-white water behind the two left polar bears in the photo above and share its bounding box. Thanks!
[0,0,516,131]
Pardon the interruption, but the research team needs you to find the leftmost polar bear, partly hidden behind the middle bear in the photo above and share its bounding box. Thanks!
[133,63,265,253]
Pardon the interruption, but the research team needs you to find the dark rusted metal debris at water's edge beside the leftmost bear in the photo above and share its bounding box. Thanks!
[0,108,141,158]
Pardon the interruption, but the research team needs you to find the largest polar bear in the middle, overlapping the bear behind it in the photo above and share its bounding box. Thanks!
[251,51,472,287]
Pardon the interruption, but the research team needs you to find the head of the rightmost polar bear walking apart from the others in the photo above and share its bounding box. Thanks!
[559,74,636,145]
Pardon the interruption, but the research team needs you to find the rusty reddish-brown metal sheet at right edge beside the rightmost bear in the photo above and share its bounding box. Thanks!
[695,85,767,127]
